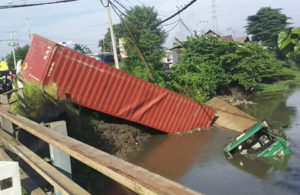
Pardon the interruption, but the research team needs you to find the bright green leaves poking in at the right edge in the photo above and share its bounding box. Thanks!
[278,27,300,58]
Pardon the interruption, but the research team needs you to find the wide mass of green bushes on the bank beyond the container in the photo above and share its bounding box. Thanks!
[167,35,294,102]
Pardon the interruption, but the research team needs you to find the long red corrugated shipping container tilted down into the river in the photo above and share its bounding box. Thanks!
[20,35,215,133]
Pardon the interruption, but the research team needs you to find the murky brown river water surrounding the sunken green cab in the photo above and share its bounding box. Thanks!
[104,85,300,195]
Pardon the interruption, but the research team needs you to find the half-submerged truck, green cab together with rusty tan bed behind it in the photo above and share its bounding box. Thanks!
[206,97,291,158]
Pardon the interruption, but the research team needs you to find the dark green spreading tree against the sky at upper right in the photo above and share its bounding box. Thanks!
[246,7,290,50]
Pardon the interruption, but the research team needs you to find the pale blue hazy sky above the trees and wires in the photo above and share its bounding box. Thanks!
[0,0,300,59]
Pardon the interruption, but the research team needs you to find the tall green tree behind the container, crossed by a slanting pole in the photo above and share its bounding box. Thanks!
[119,6,166,84]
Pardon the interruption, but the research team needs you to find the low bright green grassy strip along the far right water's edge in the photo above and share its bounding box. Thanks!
[257,71,300,95]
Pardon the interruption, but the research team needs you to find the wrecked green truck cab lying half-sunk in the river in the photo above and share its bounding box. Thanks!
[224,121,291,158]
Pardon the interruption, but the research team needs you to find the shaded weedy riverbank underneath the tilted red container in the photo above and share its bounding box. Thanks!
[11,83,151,194]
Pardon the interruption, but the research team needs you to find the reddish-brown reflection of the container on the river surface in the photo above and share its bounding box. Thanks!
[133,130,212,180]
